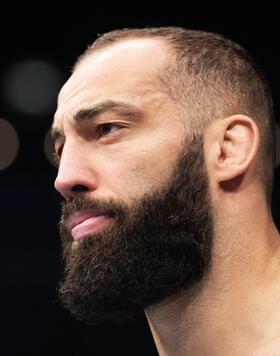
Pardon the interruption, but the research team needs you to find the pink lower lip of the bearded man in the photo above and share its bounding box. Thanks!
[71,215,110,241]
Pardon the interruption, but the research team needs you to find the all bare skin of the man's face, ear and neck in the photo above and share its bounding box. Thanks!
[53,39,280,356]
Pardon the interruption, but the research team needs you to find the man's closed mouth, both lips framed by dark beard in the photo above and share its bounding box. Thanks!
[65,209,111,241]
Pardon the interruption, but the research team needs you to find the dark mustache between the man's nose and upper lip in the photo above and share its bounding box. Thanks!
[61,194,126,223]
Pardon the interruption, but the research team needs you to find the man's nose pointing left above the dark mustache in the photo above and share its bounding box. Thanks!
[54,145,97,200]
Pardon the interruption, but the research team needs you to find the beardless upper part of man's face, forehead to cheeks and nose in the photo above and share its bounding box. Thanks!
[54,40,185,204]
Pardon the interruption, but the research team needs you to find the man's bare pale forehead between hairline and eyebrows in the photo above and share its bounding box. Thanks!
[54,39,170,125]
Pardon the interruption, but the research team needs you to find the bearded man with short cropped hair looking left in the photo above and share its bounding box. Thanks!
[53,27,280,356]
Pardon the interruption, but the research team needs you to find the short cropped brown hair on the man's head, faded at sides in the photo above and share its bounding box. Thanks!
[74,27,275,203]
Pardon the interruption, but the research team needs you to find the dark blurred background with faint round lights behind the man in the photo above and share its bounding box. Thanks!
[0,7,280,356]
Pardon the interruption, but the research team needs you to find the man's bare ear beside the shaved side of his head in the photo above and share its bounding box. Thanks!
[205,115,260,183]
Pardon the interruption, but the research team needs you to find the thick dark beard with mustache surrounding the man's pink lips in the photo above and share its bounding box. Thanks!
[59,138,212,324]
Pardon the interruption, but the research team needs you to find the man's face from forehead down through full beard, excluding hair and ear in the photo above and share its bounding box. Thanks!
[53,40,212,323]
